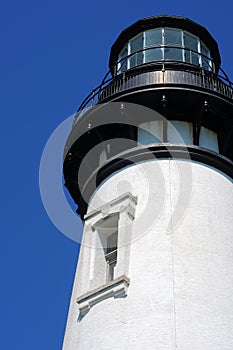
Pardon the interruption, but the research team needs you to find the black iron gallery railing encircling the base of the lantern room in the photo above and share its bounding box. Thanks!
[78,47,233,119]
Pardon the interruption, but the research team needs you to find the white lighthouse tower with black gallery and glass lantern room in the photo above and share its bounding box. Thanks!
[63,15,233,350]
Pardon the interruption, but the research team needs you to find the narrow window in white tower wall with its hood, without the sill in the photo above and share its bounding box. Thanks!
[87,193,137,289]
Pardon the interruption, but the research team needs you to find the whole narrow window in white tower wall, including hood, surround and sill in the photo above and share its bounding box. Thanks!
[77,192,137,317]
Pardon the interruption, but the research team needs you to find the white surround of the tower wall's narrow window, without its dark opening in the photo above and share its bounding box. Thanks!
[77,192,137,317]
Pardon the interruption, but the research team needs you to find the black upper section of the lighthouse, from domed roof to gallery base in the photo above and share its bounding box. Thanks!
[64,16,233,218]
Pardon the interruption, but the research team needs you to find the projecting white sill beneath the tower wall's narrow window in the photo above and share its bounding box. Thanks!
[77,276,130,317]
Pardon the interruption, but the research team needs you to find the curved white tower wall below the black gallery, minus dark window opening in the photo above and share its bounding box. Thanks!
[63,159,233,350]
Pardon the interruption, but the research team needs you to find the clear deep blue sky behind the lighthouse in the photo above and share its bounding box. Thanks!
[0,0,233,350]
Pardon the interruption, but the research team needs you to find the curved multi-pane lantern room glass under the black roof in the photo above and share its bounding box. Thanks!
[117,28,213,74]
